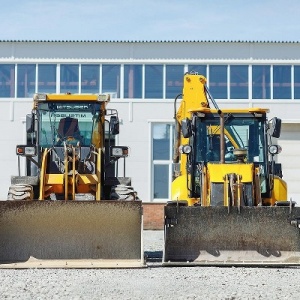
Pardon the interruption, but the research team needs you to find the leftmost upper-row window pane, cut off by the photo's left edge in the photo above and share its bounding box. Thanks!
[0,65,15,98]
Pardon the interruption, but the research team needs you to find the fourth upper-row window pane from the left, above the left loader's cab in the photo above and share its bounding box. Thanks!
[60,65,79,93]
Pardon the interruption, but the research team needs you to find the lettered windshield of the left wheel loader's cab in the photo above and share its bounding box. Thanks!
[39,103,100,148]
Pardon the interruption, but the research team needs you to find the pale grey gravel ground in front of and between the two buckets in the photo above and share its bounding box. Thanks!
[0,231,300,299]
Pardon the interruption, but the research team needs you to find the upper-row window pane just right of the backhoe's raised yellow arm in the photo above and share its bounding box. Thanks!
[209,66,227,99]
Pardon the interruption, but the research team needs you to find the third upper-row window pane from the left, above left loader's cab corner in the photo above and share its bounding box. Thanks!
[38,64,56,93]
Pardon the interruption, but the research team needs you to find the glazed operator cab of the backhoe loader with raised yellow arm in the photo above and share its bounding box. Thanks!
[190,112,269,197]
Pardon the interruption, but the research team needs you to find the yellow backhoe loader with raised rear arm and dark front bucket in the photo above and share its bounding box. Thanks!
[163,73,300,266]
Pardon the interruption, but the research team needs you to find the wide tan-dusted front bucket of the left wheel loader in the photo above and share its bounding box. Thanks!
[0,201,145,268]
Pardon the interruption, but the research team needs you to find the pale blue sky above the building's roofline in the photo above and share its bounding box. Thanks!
[0,0,300,41]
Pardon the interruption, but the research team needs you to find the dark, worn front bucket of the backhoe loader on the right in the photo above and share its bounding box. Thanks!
[163,206,300,266]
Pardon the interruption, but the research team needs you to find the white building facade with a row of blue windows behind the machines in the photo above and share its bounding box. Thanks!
[0,41,300,203]
